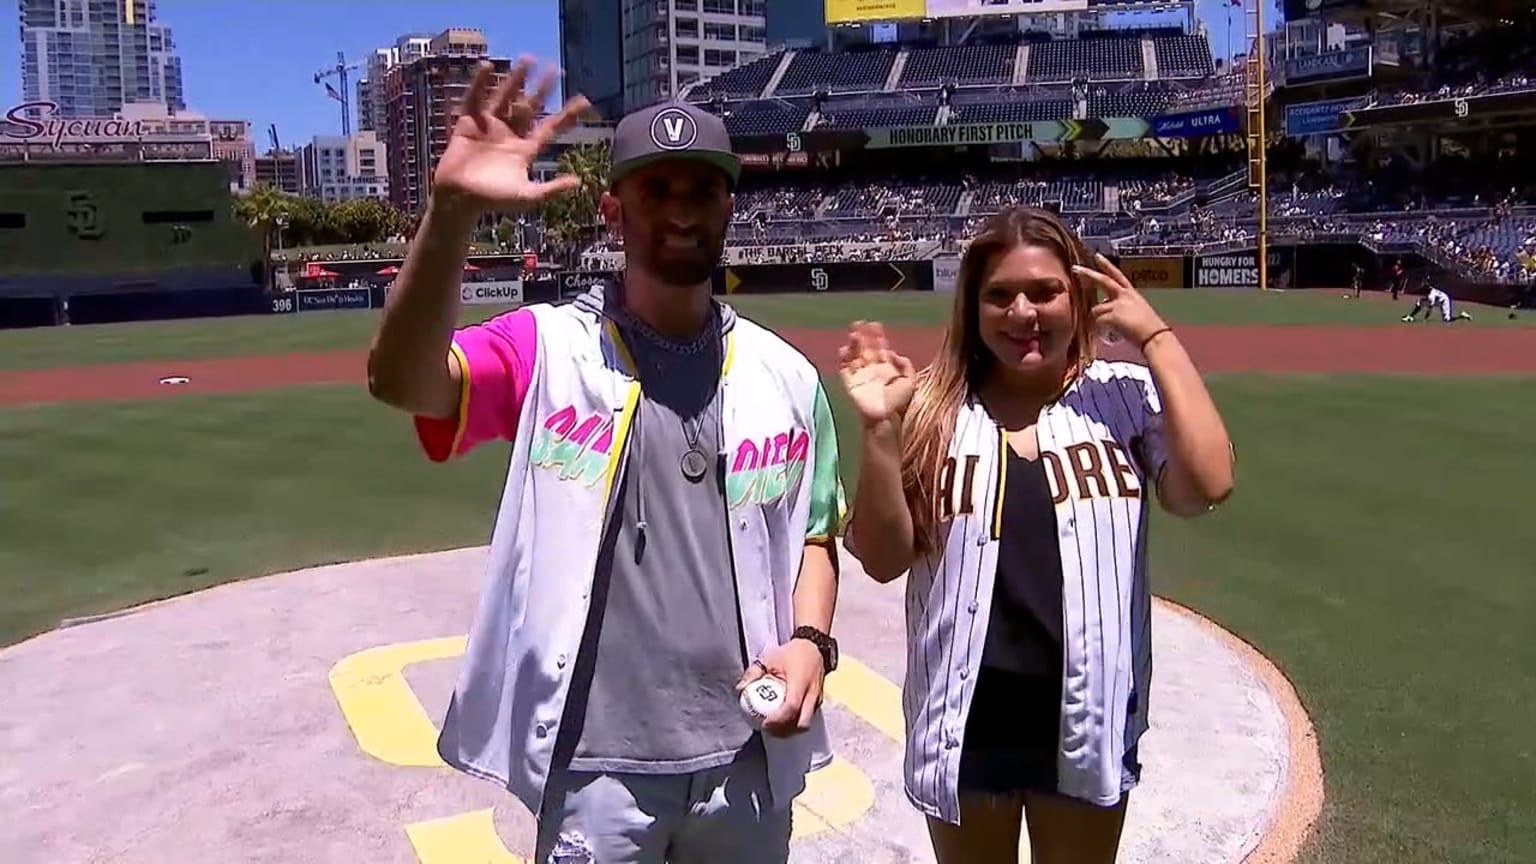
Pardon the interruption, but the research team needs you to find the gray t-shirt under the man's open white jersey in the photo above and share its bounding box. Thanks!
[565,304,753,773]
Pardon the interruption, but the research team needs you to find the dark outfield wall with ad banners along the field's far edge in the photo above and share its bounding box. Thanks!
[0,244,1528,329]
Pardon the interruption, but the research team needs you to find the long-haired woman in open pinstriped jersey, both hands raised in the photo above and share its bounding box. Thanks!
[840,209,1233,864]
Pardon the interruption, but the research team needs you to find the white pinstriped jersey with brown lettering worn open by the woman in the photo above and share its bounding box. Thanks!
[902,361,1167,822]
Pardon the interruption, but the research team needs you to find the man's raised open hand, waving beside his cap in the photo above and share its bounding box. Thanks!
[432,57,588,212]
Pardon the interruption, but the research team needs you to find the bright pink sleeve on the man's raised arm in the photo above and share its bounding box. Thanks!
[415,309,539,463]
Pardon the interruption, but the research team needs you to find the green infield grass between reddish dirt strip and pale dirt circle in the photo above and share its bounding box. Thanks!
[0,377,1536,864]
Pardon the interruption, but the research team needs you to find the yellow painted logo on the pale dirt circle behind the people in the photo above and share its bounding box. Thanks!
[330,636,884,864]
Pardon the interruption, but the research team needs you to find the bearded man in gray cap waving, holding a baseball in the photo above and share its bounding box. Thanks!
[369,58,843,864]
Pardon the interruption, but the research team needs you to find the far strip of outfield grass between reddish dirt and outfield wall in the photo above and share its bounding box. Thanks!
[0,291,1536,372]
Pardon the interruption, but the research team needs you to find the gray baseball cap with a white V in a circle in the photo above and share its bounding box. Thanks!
[608,101,742,188]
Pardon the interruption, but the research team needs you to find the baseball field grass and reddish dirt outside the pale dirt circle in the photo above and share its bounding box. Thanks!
[0,291,1536,864]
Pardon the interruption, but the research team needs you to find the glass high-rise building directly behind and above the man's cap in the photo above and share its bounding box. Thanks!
[561,0,768,120]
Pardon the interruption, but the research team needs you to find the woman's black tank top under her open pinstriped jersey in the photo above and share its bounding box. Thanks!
[982,443,1061,678]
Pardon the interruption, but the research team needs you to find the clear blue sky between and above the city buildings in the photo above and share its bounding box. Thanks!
[0,0,1278,151]
